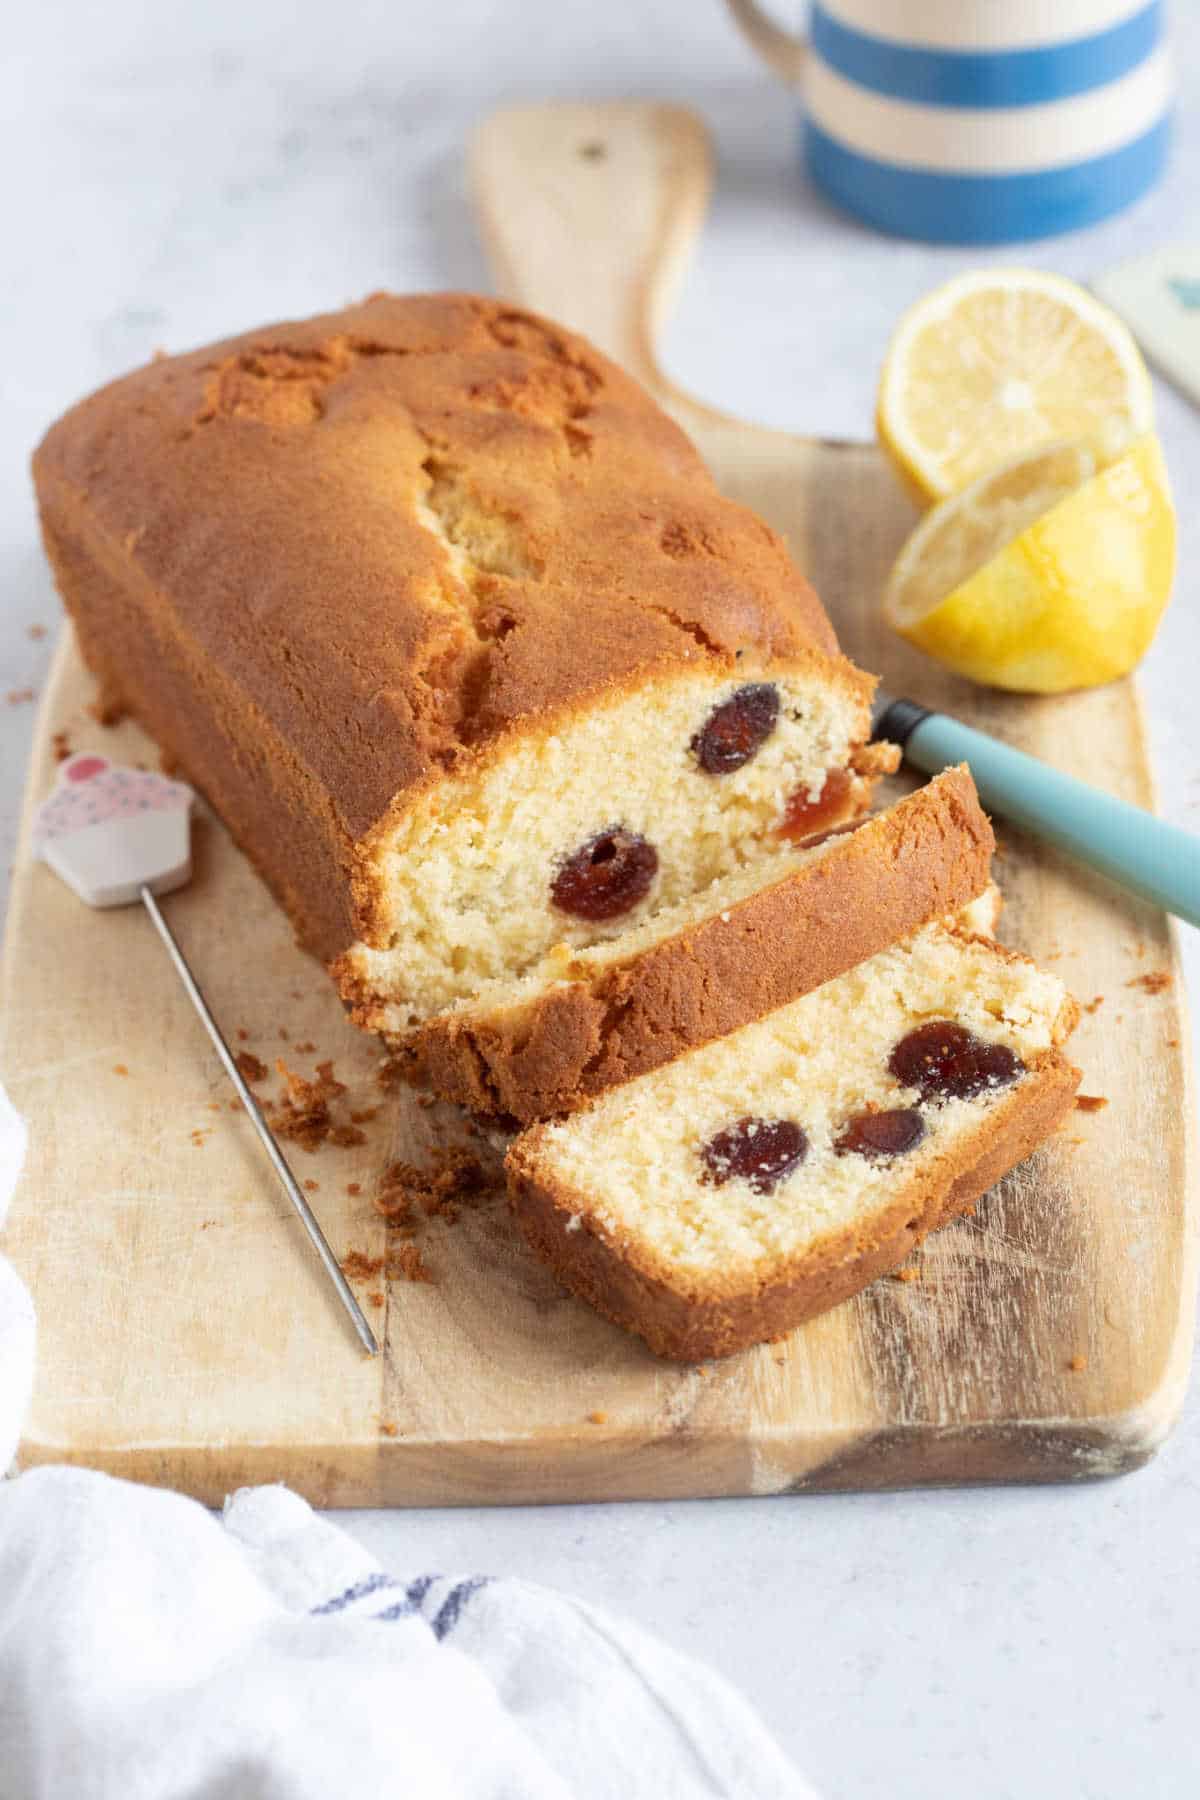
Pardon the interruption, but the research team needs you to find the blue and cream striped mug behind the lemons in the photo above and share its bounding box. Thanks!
[729,0,1171,243]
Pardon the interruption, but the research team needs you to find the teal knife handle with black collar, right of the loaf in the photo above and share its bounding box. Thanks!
[871,693,1200,925]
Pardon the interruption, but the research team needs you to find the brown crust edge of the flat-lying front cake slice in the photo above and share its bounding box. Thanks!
[506,1049,1079,1363]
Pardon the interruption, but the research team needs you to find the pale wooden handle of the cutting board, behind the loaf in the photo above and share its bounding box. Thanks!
[470,101,712,401]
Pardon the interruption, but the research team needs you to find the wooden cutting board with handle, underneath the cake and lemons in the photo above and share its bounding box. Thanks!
[0,104,1196,1505]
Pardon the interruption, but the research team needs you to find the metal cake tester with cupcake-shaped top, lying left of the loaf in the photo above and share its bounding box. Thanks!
[32,752,380,1355]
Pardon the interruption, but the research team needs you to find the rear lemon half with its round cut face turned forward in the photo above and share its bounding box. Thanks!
[876,268,1153,504]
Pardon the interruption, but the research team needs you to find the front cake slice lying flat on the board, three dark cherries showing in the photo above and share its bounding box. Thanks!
[507,923,1079,1361]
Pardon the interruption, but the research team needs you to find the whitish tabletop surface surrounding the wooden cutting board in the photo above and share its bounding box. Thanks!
[0,0,1200,1800]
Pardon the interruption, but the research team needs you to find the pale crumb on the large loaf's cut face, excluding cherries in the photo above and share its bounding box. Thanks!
[341,671,860,1028]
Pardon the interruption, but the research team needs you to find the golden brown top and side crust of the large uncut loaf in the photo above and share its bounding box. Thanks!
[34,293,871,956]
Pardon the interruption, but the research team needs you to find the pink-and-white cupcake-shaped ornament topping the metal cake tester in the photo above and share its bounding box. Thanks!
[32,751,196,905]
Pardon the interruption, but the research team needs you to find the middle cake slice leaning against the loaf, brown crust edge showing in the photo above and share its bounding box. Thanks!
[376,769,995,1123]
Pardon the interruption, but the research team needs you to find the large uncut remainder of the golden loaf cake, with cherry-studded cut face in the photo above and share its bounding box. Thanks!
[34,293,894,1028]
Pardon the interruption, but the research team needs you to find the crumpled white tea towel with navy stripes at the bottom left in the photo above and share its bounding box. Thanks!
[0,1080,813,1800]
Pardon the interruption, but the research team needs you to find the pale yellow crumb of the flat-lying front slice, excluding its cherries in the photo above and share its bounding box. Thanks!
[540,925,1067,1278]
